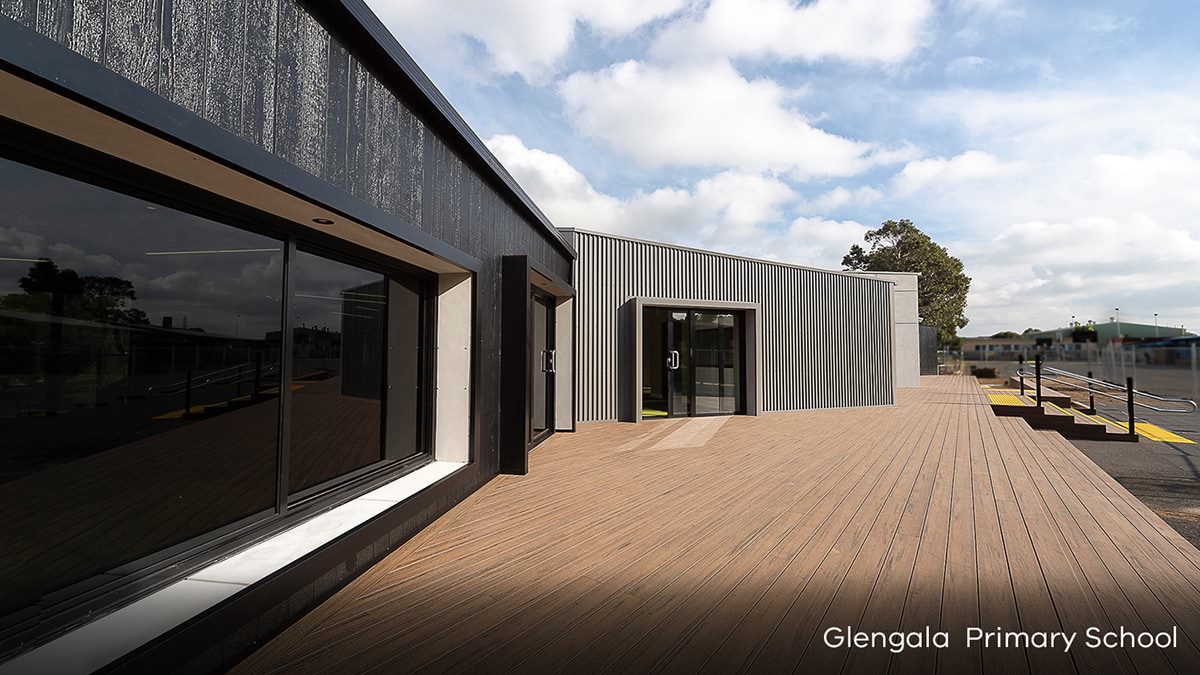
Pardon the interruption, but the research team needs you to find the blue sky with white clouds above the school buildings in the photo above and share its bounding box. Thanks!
[367,0,1200,335]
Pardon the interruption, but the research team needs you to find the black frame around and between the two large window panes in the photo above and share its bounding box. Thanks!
[0,117,441,656]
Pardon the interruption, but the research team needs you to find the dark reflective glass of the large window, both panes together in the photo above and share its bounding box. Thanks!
[0,149,430,628]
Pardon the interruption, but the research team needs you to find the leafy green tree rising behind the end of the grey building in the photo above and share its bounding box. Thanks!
[841,220,971,345]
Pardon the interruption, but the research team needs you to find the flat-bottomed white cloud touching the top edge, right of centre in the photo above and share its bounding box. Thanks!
[652,0,934,64]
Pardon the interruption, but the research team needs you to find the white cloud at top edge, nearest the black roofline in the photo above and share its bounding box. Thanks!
[368,0,690,80]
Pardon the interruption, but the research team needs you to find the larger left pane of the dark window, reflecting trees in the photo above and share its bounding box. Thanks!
[0,160,284,623]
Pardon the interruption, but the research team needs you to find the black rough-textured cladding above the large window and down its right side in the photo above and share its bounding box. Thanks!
[0,0,571,474]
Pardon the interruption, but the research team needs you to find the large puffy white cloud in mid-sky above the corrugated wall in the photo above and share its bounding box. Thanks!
[559,61,895,179]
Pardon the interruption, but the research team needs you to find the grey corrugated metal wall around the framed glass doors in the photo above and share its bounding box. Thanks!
[570,231,895,422]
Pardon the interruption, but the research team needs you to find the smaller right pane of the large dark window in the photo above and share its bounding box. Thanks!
[288,251,421,494]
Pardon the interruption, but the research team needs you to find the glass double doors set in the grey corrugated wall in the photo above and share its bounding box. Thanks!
[642,307,743,418]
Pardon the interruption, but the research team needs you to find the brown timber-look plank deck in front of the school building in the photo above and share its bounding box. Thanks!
[231,377,1200,673]
